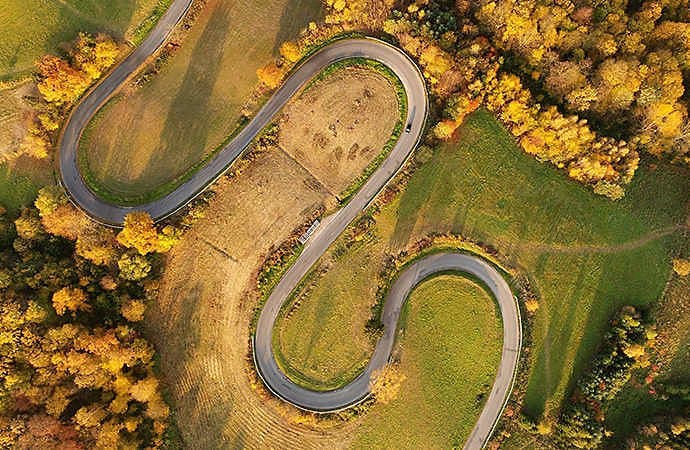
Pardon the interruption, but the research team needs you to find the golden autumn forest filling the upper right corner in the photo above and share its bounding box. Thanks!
[276,0,690,199]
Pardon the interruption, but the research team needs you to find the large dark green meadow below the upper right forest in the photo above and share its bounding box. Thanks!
[393,111,688,416]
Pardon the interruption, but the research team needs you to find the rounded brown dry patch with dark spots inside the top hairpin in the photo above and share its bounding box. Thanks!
[280,67,399,194]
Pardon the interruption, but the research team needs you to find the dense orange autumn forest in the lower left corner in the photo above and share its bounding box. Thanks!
[0,187,181,449]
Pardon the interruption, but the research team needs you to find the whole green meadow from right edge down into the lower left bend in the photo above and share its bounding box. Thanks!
[278,111,689,428]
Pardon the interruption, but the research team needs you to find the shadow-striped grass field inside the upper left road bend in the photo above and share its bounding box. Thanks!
[80,0,321,201]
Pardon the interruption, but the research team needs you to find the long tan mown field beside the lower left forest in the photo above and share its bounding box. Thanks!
[147,149,346,449]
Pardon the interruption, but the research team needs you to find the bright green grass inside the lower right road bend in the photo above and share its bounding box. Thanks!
[353,275,502,449]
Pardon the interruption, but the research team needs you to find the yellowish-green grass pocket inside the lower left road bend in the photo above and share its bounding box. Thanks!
[273,236,379,390]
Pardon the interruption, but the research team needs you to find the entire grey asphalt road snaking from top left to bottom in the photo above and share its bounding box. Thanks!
[59,0,522,449]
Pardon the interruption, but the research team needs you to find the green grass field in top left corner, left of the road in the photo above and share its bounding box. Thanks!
[0,0,161,80]
